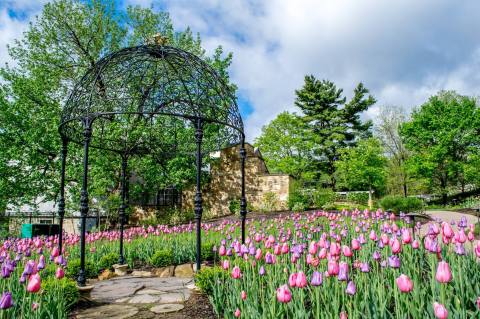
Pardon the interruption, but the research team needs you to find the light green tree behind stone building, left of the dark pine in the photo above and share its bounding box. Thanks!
[254,112,316,181]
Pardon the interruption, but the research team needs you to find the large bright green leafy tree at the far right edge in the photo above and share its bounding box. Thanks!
[400,91,480,204]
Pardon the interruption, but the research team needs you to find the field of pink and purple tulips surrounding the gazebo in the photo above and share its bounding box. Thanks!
[0,210,480,318]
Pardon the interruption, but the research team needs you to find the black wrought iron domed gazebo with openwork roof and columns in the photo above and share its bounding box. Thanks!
[58,45,247,286]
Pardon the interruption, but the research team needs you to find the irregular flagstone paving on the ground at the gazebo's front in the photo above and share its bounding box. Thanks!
[74,273,195,319]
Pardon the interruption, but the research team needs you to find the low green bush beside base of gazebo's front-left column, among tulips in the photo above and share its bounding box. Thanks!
[42,277,80,309]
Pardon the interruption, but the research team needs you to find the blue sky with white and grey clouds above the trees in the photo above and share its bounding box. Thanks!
[0,0,480,140]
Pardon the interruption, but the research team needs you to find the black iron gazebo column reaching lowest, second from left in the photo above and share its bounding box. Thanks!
[77,118,92,287]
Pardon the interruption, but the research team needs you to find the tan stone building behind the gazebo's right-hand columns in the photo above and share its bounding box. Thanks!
[182,144,292,216]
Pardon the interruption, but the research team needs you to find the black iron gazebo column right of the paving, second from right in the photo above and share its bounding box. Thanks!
[194,119,203,271]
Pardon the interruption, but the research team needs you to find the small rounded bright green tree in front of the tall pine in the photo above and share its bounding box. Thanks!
[335,138,387,196]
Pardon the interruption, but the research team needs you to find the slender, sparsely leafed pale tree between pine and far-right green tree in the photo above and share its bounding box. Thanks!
[375,106,412,197]
